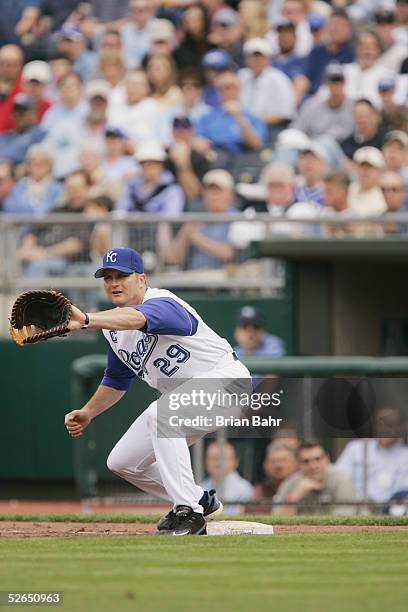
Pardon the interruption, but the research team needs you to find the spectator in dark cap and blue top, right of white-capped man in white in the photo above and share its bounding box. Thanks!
[272,19,307,80]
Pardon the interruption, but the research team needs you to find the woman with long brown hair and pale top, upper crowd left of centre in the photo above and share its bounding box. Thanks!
[146,55,182,110]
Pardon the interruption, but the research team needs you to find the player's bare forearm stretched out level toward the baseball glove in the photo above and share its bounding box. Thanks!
[68,306,146,331]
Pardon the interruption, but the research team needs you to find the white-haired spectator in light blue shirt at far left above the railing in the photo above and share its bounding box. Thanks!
[4,144,63,216]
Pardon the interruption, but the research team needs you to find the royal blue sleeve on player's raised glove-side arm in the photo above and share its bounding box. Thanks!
[135,298,198,336]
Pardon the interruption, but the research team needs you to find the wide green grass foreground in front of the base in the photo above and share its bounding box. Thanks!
[0,531,408,612]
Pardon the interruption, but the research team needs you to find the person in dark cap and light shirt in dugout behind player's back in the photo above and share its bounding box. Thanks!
[234,306,286,358]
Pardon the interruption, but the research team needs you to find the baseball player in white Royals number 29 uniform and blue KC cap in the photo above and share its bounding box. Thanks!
[65,248,250,535]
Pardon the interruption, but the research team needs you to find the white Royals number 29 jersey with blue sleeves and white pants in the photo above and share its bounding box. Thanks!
[101,288,250,513]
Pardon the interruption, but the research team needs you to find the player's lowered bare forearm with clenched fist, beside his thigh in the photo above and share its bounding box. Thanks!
[65,385,126,438]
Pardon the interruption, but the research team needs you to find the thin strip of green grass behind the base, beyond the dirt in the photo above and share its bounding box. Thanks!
[0,512,408,529]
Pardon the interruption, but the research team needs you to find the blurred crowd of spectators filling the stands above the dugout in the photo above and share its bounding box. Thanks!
[0,0,408,276]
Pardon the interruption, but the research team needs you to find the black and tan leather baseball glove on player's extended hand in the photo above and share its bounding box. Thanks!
[10,290,72,346]
